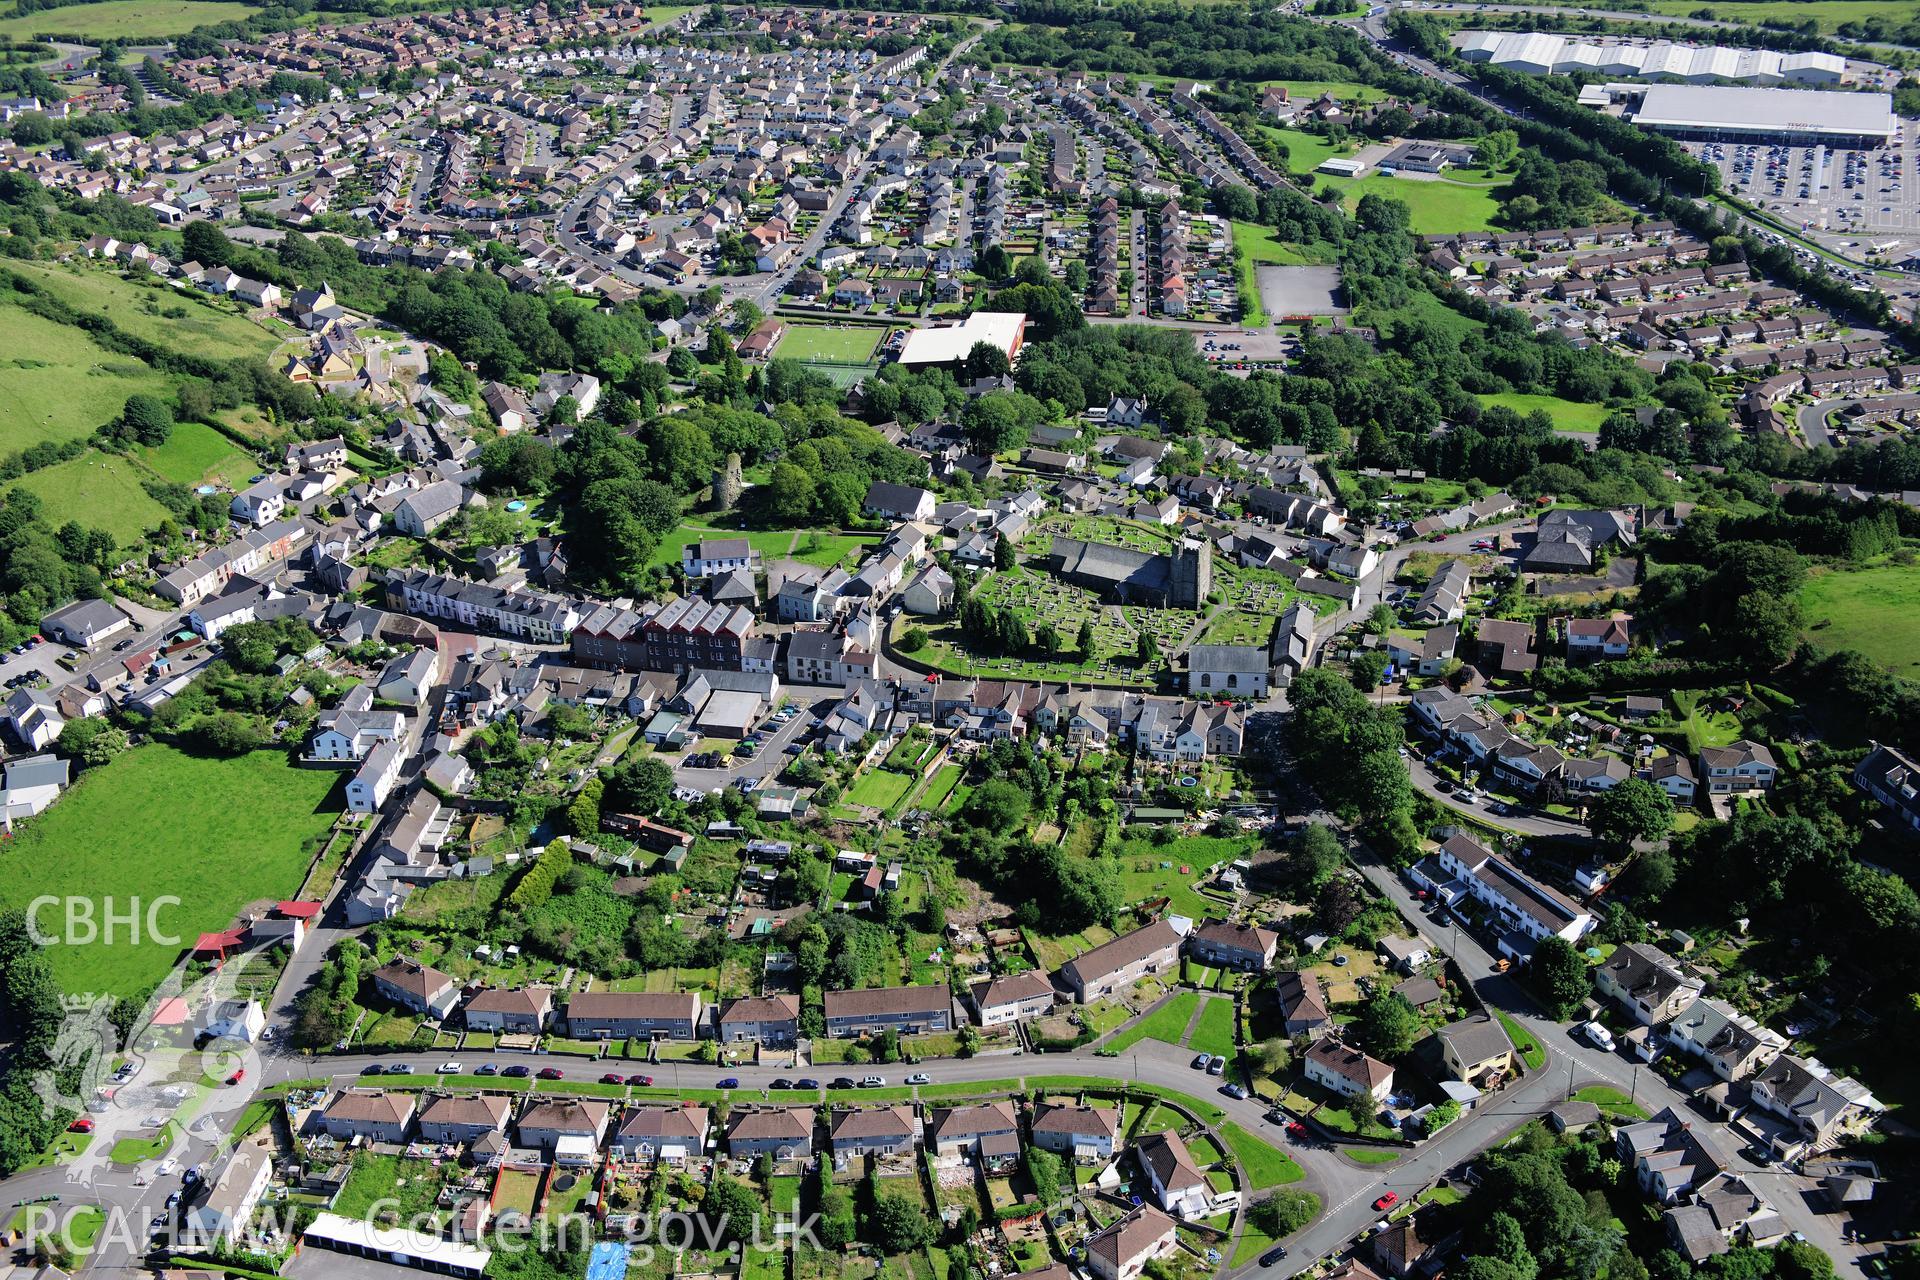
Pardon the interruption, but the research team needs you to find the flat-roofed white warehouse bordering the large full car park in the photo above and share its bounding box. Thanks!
[1620,84,1899,146]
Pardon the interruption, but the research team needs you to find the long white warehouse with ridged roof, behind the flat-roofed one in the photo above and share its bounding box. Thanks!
[1453,31,1847,84]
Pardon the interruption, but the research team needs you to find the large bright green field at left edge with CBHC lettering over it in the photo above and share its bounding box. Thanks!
[0,743,340,994]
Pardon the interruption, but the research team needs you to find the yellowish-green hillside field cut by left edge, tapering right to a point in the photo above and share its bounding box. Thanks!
[0,307,171,453]
